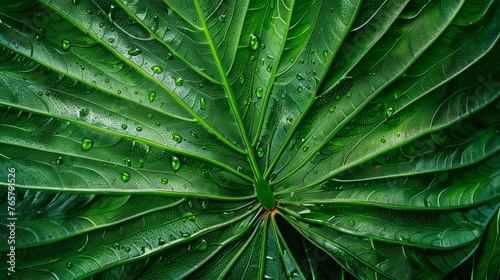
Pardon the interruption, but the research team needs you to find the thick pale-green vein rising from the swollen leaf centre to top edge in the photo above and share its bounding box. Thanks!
[194,0,275,210]
